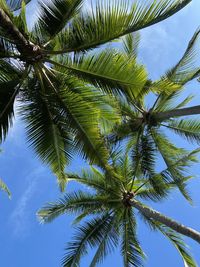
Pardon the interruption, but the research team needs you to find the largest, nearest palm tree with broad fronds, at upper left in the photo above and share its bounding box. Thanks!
[0,0,191,189]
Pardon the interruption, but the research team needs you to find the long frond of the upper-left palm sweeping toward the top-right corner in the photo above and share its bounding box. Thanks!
[49,0,191,53]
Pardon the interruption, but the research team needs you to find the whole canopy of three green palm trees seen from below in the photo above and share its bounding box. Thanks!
[0,0,200,267]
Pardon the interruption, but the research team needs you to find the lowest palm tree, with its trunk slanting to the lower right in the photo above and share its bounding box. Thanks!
[38,151,200,267]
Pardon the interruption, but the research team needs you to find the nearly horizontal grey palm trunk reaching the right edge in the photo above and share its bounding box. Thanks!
[155,106,200,120]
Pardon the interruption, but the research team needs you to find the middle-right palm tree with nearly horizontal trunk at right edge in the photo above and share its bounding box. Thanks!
[99,30,200,199]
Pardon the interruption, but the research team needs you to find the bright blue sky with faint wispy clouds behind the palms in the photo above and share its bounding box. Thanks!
[0,0,200,267]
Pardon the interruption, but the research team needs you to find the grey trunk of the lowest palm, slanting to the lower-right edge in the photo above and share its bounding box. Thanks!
[130,199,200,243]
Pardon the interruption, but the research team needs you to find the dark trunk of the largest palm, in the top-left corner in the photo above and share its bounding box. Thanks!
[0,8,29,54]
